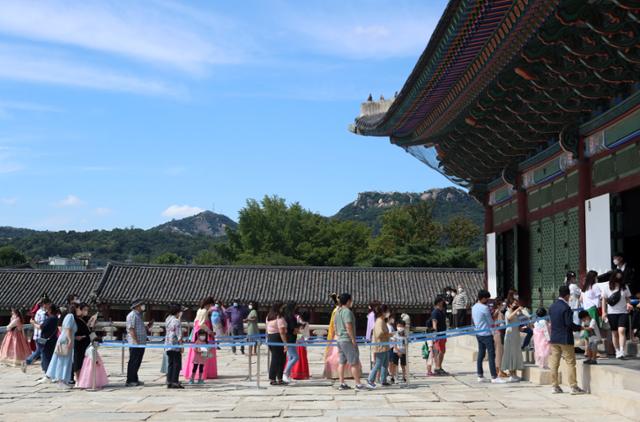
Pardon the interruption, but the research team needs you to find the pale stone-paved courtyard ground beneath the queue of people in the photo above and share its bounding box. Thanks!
[0,344,629,422]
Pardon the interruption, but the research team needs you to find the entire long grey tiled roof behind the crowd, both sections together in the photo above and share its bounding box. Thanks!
[0,262,484,310]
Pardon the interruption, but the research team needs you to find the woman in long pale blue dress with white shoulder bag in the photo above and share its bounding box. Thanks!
[47,303,81,388]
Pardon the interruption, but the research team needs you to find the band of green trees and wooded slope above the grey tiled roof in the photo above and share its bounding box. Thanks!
[0,196,483,267]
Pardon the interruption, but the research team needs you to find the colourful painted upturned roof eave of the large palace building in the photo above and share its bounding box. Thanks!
[350,0,640,191]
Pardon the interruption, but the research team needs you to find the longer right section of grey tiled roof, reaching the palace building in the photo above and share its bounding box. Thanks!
[99,263,484,308]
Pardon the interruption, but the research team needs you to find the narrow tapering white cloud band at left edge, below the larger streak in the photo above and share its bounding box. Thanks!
[0,44,180,96]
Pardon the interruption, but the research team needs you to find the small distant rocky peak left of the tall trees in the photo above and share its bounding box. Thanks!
[150,211,238,237]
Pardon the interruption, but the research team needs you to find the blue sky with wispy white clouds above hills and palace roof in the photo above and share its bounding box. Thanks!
[0,0,450,230]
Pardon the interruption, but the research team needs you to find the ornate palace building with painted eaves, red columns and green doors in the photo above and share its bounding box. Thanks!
[350,0,640,304]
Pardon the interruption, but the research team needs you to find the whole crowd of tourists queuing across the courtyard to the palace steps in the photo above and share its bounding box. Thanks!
[0,255,640,394]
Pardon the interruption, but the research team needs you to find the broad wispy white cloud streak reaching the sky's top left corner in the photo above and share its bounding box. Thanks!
[0,0,246,73]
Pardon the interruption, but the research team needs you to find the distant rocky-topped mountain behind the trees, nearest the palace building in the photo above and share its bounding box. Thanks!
[333,188,484,233]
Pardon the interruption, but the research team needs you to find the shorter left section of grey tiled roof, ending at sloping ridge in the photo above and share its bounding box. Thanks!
[0,269,104,310]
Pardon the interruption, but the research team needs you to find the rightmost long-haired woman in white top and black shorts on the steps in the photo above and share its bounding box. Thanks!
[602,270,632,359]
